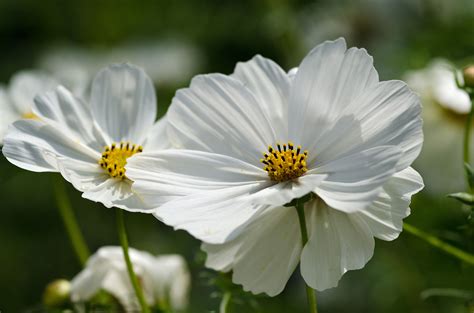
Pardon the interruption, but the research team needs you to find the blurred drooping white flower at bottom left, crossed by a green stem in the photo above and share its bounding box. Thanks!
[71,246,191,312]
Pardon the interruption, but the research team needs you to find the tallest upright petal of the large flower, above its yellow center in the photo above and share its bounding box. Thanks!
[288,38,378,147]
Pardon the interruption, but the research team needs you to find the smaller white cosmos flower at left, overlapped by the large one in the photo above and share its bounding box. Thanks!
[3,64,169,212]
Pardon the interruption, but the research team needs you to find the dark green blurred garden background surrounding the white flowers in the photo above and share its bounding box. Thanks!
[0,0,474,313]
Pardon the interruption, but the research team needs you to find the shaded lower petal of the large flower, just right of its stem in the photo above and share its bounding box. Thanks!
[301,199,374,291]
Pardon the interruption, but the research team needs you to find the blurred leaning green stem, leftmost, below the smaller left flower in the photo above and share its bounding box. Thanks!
[53,177,90,266]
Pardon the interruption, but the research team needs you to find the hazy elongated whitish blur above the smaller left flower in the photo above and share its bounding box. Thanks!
[39,40,201,85]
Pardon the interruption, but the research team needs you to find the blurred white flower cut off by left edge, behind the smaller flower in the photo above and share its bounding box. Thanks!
[0,71,58,144]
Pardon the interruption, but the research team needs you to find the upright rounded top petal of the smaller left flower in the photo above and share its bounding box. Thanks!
[91,64,157,144]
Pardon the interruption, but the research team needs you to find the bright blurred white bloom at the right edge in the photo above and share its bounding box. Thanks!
[405,59,471,114]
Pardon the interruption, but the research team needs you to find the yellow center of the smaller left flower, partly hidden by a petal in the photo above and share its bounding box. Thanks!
[99,142,143,179]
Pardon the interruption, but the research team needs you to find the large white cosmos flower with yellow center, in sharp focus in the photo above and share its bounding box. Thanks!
[126,39,423,296]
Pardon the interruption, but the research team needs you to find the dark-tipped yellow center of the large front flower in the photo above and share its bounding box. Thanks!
[260,141,308,182]
